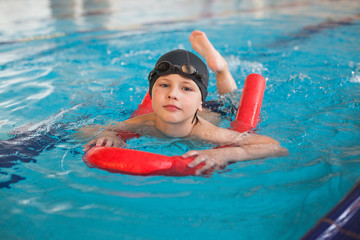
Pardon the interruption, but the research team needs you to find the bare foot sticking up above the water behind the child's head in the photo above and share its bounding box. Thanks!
[189,30,226,73]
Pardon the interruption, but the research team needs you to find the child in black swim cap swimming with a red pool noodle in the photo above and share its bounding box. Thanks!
[82,31,288,174]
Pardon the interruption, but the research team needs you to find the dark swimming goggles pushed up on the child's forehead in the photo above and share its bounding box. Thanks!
[149,61,203,81]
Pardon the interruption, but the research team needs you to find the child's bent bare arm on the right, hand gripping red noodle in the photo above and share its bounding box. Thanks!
[186,121,288,174]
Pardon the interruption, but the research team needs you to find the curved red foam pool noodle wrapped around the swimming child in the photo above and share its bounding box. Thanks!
[84,74,265,176]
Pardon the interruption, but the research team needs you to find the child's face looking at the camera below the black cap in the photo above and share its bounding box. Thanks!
[152,74,202,123]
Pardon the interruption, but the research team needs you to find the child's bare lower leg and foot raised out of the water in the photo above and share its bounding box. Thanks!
[189,30,237,95]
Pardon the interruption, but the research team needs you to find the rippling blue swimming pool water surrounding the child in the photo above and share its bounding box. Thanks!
[0,0,360,239]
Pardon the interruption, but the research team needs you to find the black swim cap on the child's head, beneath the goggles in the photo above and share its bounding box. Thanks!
[149,49,209,102]
